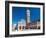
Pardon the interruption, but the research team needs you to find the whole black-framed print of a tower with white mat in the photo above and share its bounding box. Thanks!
[5,1,45,37]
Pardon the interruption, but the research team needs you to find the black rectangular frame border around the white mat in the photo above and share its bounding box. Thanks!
[5,1,45,37]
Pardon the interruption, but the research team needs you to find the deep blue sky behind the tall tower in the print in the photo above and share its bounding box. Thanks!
[12,7,40,24]
